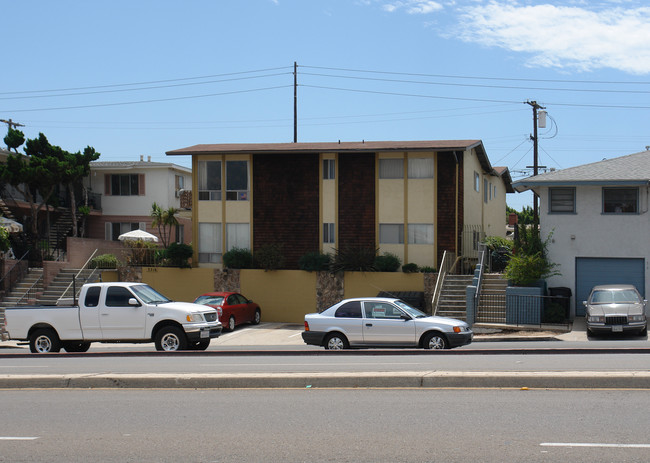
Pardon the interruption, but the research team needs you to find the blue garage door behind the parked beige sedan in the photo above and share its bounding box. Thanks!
[575,257,645,316]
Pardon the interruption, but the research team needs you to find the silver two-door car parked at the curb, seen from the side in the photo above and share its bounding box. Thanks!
[302,297,473,349]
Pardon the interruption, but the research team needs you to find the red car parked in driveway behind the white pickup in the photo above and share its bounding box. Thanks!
[194,292,262,331]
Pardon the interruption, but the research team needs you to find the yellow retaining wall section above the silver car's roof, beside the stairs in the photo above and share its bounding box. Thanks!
[344,272,424,299]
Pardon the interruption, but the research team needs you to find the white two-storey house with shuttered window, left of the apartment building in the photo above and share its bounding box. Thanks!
[85,156,192,243]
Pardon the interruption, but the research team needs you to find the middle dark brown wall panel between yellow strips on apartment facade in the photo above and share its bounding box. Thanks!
[337,153,377,248]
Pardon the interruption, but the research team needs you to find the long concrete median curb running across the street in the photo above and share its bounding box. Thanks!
[0,371,650,389]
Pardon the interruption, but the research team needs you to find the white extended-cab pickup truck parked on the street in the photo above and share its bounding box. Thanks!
[5,283,222,353]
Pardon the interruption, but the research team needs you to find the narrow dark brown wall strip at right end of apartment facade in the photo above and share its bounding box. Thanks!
[436,152,464,263]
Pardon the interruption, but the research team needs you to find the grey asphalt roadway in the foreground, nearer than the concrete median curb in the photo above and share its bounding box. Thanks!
[0,389,650,463]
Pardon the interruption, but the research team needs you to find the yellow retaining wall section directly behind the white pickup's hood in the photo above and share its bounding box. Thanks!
[142,267,214,302]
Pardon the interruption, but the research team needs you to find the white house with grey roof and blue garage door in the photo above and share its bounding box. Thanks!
[513,150,650,317]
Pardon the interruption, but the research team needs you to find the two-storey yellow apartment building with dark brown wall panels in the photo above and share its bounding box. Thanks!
[167,140,513,268]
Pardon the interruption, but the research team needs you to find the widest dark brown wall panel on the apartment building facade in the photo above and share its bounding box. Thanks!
[252,153,320,269]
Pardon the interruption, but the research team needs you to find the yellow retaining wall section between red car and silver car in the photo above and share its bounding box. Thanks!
[240,270,316,323]
